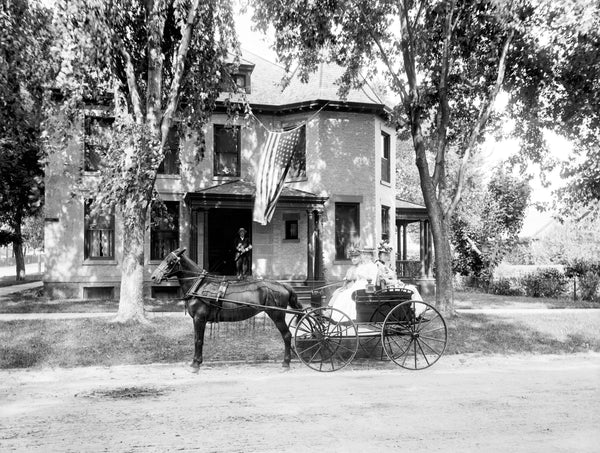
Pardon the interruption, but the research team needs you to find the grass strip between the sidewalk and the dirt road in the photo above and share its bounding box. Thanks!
[0,314,600,369]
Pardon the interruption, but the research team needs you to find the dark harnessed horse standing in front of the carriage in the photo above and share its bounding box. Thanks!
[151,247,304,371]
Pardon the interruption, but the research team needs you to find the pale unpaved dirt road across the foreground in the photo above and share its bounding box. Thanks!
[0,354,600,453]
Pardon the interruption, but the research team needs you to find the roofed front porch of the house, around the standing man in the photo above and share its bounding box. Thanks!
[184,180,327,286]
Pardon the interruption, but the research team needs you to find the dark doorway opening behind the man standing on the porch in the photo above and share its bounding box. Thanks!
[207,208,252,275]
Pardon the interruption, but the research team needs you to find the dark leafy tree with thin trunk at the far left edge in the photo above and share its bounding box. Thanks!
[0,0,52,278]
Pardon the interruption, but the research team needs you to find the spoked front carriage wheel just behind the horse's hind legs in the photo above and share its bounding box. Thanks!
[294,307,358,372]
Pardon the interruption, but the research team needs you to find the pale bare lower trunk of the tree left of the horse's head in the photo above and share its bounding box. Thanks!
[115,202,148,323]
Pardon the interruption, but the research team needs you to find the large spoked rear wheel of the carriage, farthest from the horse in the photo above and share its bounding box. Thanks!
[381,300,448,370]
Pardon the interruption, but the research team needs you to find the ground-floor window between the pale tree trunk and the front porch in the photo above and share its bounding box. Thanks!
[150,201,179,260]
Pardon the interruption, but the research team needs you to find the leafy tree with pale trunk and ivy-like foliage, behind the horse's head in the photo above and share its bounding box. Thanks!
[51,0,239,321]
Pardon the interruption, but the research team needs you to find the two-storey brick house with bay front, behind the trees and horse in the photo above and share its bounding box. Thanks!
[44,49,429,298]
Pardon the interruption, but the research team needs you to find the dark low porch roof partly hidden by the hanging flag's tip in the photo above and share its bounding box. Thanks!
[184,179,328,209]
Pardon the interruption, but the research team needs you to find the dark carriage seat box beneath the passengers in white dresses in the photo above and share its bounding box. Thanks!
[352,287,413,322]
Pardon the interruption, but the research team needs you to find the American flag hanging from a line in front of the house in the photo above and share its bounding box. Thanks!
[253,127,302,225]
